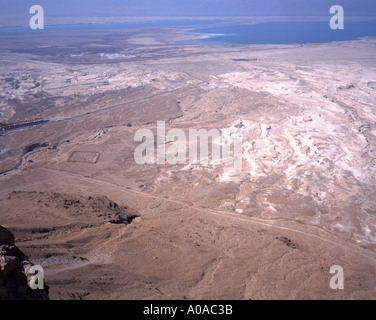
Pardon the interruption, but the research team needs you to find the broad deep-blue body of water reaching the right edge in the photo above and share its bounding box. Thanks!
[179,19,376,45]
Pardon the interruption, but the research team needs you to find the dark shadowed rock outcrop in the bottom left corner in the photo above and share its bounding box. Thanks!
[0,226,49,300]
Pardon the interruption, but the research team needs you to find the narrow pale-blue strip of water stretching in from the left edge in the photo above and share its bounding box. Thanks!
[0,20,223,33]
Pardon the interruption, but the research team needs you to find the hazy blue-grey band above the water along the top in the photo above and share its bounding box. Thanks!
[0,0,376,17]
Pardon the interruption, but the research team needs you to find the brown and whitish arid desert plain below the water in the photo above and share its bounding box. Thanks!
[0,21,376,299]
